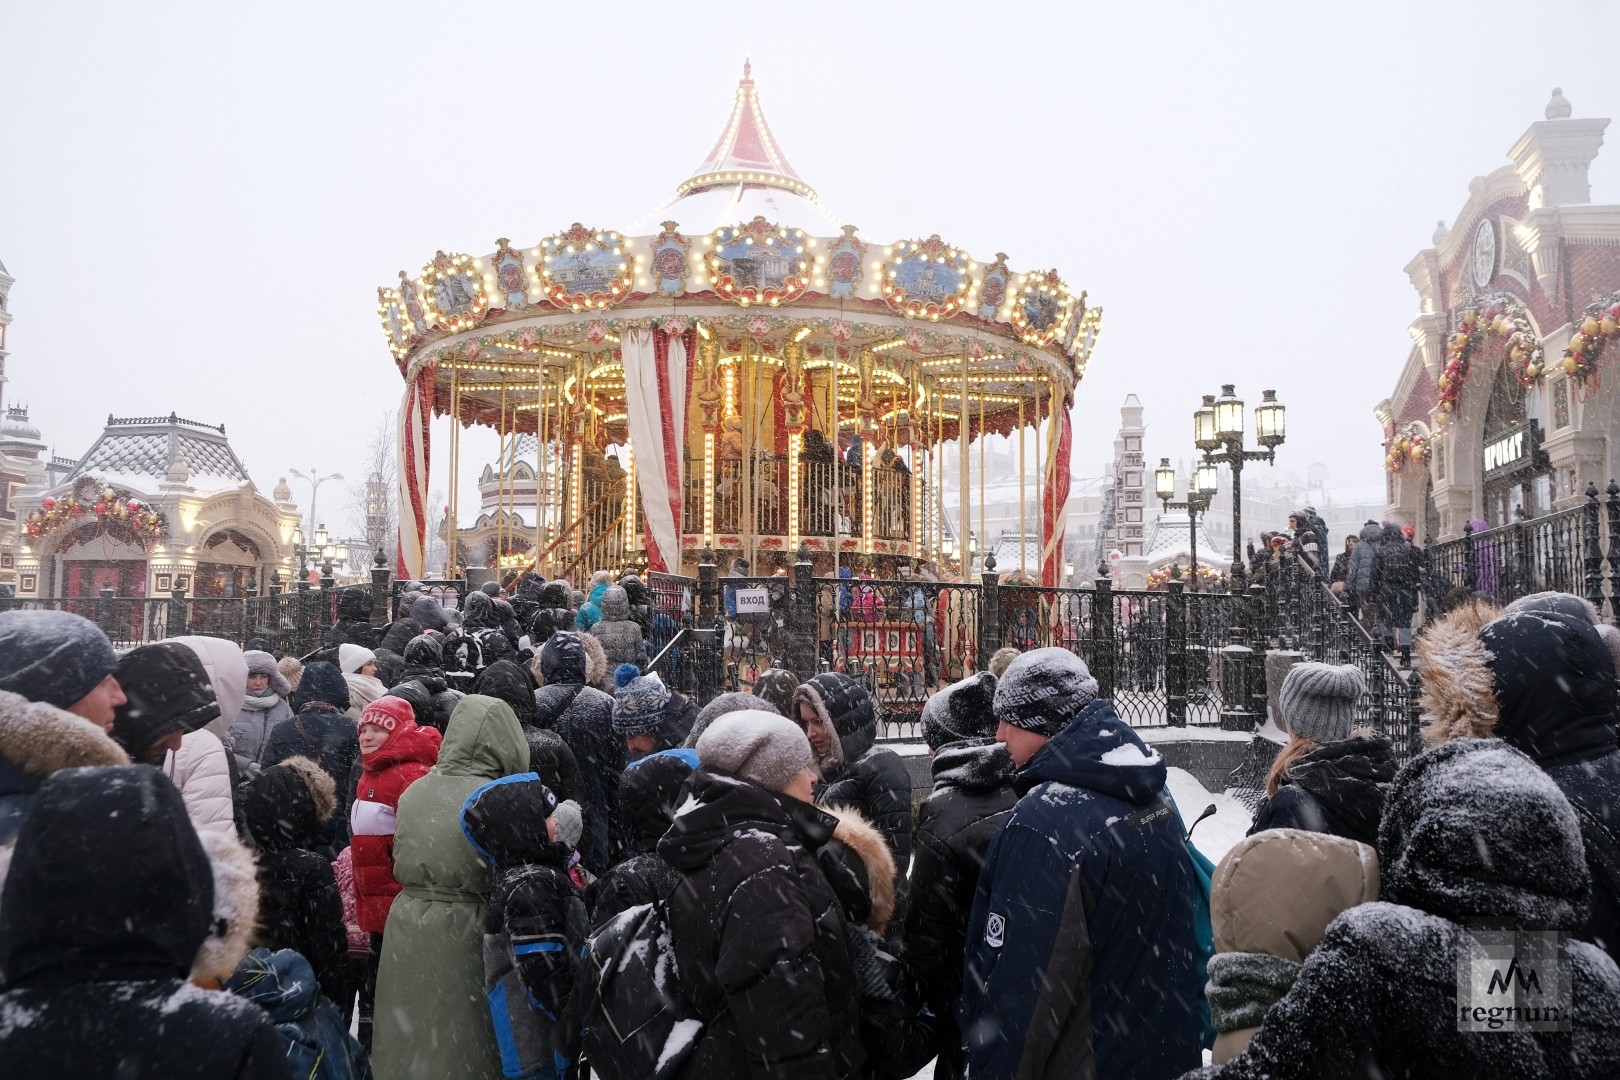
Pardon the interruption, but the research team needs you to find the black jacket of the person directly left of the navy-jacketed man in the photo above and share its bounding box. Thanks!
[906,743,1017,1080]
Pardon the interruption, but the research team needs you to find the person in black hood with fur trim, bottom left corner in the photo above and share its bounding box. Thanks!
[0,766,288,1080]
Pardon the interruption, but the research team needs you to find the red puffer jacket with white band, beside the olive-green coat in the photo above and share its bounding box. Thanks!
[348,724,444,934]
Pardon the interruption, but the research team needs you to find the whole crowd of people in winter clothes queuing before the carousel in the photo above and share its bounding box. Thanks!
[0,575,1620,1080]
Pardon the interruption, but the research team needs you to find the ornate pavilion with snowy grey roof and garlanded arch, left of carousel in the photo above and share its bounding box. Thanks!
[11,413,298,605]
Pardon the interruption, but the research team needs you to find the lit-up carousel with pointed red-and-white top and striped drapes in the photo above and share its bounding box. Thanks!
[377,66,1102,583]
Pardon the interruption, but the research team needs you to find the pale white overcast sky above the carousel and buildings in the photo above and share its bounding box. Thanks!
[0,0,1620,528]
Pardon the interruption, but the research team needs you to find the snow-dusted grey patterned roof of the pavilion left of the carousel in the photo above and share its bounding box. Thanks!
[63,413,248,494]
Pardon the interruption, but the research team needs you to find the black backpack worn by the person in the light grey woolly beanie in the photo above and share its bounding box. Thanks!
[578,900,705,1080]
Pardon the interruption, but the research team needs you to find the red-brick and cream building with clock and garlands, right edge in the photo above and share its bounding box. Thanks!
[1375,89,1620,541]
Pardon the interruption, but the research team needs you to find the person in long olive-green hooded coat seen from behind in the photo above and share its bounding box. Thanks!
[371,695,528,1080]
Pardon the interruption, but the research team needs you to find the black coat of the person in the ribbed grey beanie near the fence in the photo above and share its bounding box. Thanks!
[1249,735,1396,845]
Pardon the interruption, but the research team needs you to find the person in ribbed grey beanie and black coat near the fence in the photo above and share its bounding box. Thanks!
[1249,664,1395,844]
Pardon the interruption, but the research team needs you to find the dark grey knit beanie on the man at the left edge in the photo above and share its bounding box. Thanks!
[0,610,118,709]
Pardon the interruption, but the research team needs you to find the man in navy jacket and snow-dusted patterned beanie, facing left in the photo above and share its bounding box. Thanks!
[957,648,1202,1080]
